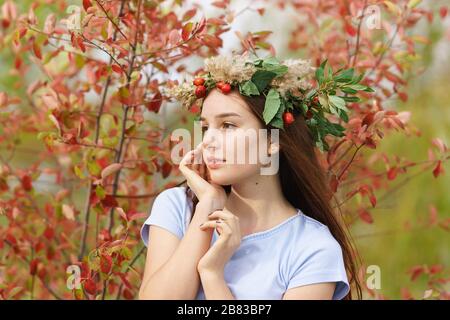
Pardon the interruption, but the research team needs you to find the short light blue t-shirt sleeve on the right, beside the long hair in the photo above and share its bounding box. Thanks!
[287,227,350,300]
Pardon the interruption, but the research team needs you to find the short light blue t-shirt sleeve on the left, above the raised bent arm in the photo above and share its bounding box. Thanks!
[141,187,186,247]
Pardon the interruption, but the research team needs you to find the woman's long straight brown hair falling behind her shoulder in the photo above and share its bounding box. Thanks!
[181,89,362,300]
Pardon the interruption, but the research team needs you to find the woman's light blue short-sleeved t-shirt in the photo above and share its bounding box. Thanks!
[141,187,350,300]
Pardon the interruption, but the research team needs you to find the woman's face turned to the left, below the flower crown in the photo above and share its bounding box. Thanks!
[200,89,267,185]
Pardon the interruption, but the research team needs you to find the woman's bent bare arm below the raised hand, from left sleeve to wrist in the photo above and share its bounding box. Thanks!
[139,199,215,300]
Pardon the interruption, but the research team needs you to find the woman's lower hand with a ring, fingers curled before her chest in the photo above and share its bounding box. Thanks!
[197,209,241,274]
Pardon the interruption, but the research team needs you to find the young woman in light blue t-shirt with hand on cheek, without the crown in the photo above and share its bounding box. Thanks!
[139,53,361,299]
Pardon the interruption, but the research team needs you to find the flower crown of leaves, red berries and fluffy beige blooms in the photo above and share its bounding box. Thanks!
[164,54,373,152]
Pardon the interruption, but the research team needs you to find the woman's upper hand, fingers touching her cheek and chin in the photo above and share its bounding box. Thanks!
[179,142,227,210]
